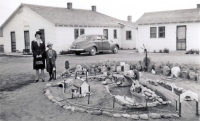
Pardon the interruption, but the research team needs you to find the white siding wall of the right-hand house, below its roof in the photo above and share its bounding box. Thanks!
[136,23,200,52]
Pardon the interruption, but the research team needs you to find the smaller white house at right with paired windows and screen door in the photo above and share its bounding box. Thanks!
[136,4,200,52]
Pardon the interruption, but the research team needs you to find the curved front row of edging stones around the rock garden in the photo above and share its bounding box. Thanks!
[44,83,179,120]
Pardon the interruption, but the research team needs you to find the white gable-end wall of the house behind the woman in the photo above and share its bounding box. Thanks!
[3,7,56,52]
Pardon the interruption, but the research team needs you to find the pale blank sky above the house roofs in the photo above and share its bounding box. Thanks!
[0,0,200,25]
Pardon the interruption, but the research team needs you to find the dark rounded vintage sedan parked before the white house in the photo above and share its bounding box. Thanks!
[69,35,119,56]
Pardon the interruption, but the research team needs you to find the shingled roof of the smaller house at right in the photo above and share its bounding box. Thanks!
[136,8,200,25]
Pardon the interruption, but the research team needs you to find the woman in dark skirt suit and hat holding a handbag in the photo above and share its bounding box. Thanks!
[31,31,45,82]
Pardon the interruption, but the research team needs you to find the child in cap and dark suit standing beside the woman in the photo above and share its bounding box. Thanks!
[46,42,57,81]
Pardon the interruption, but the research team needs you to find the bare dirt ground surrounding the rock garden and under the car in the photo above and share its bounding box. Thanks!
[0,51,200,121]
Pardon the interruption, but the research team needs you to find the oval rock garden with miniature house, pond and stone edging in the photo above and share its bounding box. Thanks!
[44,57,200,120]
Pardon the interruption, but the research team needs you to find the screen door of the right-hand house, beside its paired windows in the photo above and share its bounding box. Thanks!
[176,26,186,50]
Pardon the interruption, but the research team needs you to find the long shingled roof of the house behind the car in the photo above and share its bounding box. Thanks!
[23,4,136,27]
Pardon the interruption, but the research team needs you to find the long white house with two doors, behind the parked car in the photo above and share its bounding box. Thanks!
[0,3,137,52]
